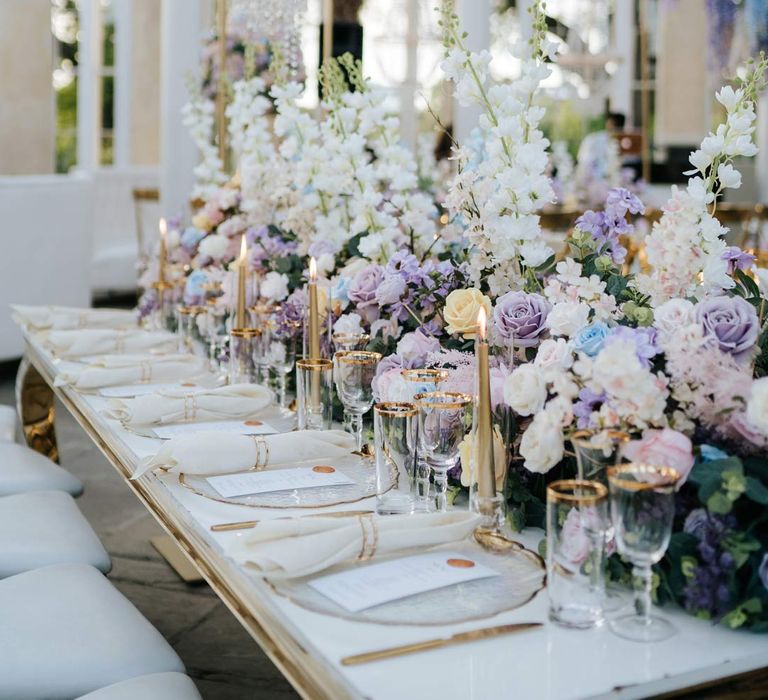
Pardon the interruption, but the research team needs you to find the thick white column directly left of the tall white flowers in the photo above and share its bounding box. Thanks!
[160,0,205,216]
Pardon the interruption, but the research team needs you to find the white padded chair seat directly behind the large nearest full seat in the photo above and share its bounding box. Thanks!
[0,491,112,576]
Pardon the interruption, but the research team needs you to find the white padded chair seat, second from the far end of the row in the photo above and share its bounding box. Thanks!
[0,441,83,496]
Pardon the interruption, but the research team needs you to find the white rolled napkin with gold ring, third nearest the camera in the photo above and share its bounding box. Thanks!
[104,384,272,426]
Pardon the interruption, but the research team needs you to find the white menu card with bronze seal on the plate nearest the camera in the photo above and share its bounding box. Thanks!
[308,552,500,612]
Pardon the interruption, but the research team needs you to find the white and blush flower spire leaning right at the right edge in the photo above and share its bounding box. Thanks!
[637,54,768,306]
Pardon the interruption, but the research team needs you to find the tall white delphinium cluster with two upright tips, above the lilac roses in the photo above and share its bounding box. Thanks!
[440,2,555,294]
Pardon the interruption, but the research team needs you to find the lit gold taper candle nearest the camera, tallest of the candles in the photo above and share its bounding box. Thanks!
[475,308,496,498]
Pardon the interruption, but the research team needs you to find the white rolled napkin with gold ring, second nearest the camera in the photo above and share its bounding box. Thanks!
[133,430,355,479]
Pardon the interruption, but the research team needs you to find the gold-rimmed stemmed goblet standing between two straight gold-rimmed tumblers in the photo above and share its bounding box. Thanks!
[333,350,381,450]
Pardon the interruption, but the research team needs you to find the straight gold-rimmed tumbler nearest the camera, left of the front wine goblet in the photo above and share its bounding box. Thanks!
[547,479,608,629]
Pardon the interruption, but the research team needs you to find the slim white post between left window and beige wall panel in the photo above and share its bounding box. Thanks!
[113,0,133,168]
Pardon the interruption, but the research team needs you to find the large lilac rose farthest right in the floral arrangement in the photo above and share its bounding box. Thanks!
[696,296,760,360]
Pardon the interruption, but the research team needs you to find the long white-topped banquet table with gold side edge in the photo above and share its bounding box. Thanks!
[17,331,768,700]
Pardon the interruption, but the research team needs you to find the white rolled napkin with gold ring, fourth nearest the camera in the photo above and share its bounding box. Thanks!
[54,354,207,391]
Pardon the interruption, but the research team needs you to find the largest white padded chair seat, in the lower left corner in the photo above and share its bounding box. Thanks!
[0,564,184,700]
